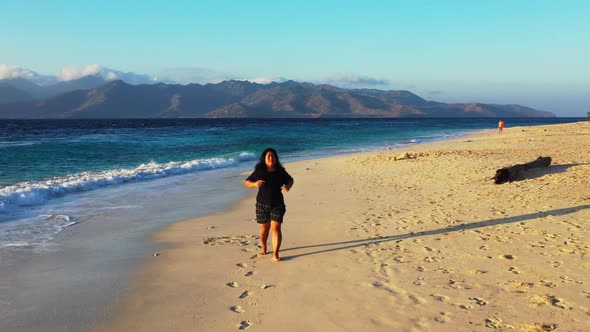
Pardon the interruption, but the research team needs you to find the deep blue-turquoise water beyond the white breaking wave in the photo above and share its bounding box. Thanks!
[0,118,583,186]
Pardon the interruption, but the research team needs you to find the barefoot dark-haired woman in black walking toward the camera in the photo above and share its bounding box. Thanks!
[244,148,293,262]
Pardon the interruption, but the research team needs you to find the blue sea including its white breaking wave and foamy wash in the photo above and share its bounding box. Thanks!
[0,118,584,249]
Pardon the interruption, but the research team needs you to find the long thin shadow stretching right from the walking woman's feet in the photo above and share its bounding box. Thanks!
[281,204,590,260]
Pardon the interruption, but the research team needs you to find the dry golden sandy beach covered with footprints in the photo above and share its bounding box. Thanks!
[96,121,590,331]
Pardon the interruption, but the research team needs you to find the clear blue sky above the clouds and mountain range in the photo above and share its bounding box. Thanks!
[0,0,590,116]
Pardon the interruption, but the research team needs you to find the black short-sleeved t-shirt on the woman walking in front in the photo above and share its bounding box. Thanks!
[246,167,293,206]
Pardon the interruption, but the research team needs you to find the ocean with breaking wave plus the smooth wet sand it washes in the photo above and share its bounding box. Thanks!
[0,118,586,330]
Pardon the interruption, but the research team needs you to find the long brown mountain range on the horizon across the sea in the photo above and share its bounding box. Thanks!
[0,76,555,119]
